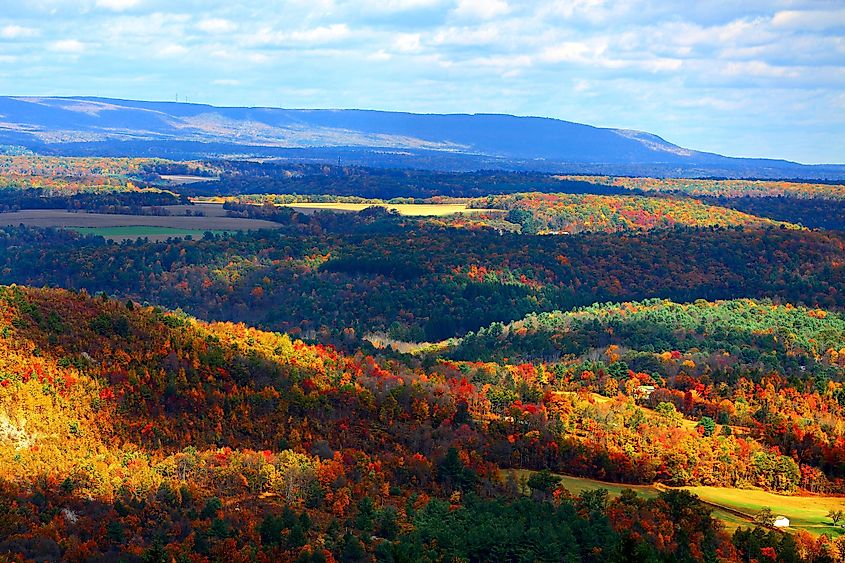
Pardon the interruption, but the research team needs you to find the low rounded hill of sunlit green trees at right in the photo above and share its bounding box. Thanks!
[452,299,845,377]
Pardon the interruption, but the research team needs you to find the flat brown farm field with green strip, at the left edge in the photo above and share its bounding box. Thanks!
[0,206,279,240]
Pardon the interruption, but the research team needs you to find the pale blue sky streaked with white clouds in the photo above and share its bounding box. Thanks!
[0,0,845,163]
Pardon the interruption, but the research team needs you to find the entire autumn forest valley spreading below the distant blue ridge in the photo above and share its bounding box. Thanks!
[0,155,845,563]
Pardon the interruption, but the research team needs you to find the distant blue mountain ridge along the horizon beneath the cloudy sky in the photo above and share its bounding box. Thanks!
[0,96,845,179]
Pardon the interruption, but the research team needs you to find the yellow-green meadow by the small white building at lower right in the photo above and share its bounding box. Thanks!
[508,470,845,537]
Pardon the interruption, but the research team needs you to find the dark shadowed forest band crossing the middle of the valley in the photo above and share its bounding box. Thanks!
[0,223,845,341]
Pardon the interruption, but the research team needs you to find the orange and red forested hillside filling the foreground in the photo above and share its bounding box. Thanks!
[0,287,845,561]
